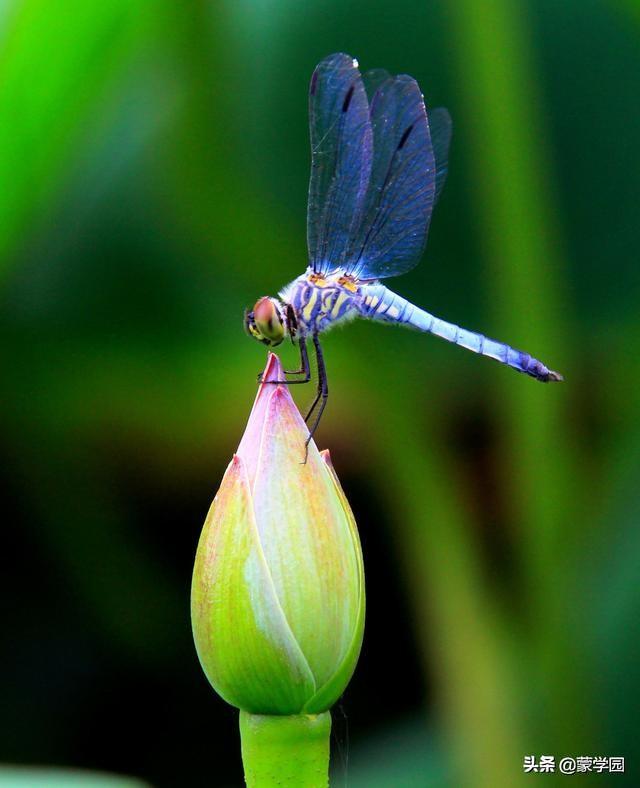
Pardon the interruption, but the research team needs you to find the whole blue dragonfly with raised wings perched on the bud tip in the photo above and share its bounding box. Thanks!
[245,53,563,444]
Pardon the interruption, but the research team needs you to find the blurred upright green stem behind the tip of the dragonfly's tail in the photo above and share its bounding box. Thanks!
[450,0,589,760]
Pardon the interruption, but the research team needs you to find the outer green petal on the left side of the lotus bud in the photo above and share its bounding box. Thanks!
[191,456,315,714]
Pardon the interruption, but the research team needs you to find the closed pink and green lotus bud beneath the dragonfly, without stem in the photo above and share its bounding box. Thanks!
[191,355,365,715]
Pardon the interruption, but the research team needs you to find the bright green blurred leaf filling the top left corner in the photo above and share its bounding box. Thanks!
[0,0,162,270]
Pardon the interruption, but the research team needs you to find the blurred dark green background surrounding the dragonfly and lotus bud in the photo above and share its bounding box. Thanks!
[0,0,640,788]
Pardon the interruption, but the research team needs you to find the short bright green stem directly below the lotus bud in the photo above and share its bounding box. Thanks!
[240,711,331,788]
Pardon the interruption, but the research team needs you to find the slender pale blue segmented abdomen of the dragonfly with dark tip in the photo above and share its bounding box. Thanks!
[362,284,562,383]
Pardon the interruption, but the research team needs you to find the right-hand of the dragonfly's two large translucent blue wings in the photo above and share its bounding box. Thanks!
[346,75,436,279]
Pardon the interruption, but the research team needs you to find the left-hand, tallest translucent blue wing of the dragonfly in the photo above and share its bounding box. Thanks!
[307,54,373,273]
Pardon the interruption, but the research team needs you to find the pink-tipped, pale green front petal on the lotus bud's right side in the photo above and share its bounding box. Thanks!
[253,387,360,687]
